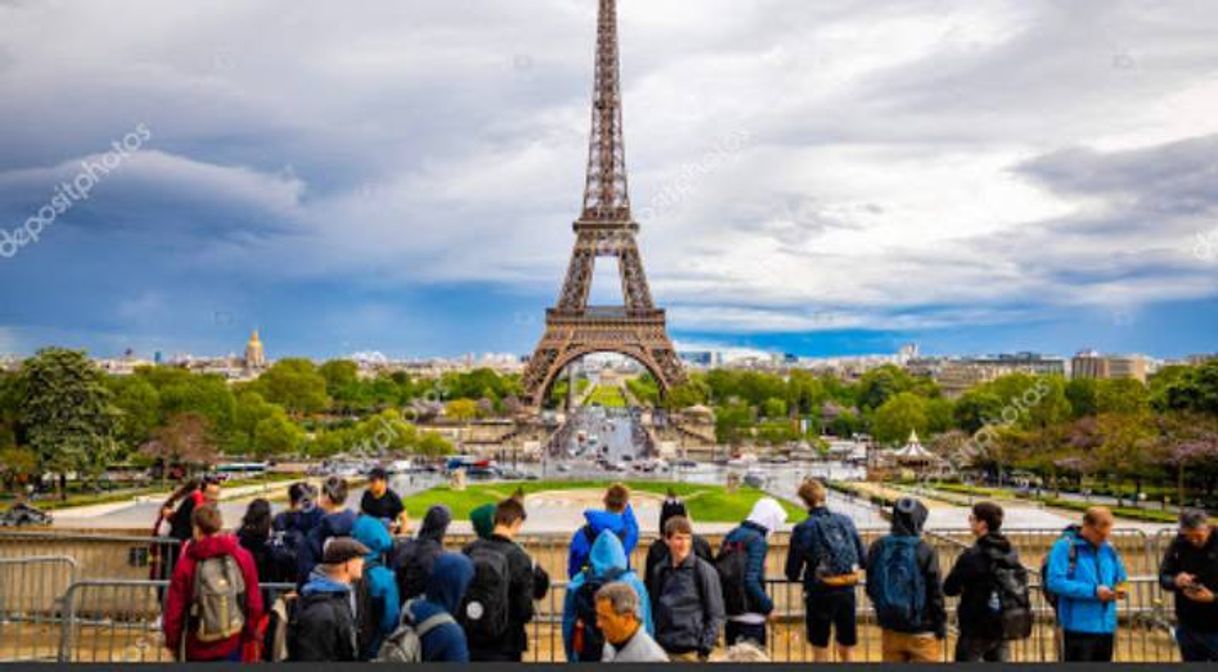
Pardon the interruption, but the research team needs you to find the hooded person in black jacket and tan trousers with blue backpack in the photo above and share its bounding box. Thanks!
[867,497,948,662]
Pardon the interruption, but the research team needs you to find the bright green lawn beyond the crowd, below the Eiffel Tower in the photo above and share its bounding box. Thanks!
[406,481,804,522]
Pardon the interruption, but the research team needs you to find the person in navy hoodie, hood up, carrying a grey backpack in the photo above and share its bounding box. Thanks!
[406,553,474,662]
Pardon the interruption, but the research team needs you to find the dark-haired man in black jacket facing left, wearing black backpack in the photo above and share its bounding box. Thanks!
[943,502,1019,662]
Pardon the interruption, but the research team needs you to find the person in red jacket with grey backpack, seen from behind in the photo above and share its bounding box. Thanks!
[163,505,263,661]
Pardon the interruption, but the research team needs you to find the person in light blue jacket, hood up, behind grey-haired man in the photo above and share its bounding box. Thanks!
[563,530,655,662]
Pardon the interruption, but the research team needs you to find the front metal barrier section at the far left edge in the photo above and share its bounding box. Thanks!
[0,556,78,661]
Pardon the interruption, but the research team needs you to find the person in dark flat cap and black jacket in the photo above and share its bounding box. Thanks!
[287,537,371,662]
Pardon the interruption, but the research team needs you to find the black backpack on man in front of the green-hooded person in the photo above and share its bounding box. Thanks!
[458,542,512,648]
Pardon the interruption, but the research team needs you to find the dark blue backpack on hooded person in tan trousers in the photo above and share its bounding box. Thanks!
[867,537,926,623]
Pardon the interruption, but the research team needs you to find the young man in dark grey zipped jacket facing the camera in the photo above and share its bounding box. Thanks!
[647,516,726,662]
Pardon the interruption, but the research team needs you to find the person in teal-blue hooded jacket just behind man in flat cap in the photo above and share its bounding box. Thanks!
[351,515,402,660]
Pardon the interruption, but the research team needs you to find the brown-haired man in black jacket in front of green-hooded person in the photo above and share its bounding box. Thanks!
[458,498,549,662]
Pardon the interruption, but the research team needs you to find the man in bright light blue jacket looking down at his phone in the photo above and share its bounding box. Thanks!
[1045,506,1129,662]
